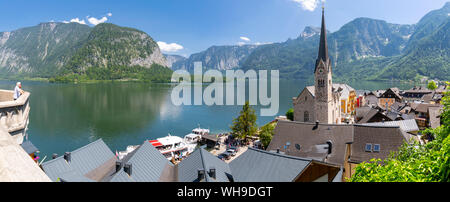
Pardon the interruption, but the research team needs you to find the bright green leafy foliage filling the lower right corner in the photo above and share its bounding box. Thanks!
[349,82,450,182]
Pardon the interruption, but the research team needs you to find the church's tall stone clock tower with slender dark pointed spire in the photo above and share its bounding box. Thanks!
[314,6,335,124]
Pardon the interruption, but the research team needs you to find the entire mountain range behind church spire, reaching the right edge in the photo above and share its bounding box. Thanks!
[241,3,450,80]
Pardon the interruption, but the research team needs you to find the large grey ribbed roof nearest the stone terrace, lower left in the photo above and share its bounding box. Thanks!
[42,139,118,182]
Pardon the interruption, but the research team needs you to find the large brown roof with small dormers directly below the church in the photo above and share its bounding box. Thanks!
[267,121,411,180]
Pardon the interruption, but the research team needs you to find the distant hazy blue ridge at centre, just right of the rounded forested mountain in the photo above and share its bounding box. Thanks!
[172,45,258,71]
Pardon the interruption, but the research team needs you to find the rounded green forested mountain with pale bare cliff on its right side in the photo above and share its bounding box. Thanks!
[66,23,167,72]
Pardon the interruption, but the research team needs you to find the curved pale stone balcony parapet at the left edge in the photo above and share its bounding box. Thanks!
[0,90,30,144]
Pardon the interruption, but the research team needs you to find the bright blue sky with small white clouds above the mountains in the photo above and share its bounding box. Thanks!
[0,0,449,57]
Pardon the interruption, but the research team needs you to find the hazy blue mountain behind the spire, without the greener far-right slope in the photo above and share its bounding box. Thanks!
[242,18,414,79]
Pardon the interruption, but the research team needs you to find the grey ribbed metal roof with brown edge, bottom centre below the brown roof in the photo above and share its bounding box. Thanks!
[229,148,342,182]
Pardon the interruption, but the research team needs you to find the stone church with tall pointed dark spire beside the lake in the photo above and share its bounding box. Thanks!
[293,8,355,124]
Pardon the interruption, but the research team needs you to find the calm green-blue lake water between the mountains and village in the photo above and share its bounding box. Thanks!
[0,81,413,160]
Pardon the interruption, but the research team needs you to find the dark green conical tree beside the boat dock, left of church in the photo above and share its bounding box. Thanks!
[230,101,258,140]
